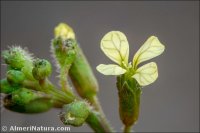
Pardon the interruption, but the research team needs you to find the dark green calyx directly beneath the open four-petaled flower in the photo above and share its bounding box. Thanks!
[117,75,141,127]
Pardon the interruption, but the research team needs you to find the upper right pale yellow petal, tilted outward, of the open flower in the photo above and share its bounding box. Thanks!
[133,36,165,68]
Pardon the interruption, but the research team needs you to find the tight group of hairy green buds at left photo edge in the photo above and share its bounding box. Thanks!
[0,46,53,113]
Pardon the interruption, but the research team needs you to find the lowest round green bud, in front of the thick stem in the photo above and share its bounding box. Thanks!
[60,101,91,126]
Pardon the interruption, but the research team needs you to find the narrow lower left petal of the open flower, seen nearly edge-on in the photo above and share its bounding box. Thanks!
[96,64,126,75]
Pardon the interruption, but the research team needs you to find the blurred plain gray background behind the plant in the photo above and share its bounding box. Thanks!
[1,1,199,132]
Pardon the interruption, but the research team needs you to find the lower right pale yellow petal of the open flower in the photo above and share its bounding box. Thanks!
[132,62,158,86]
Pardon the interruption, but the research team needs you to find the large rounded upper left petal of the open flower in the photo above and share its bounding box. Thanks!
[101,31,129,65]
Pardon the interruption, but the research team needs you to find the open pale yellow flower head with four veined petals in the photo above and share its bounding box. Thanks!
[97,31,165,86]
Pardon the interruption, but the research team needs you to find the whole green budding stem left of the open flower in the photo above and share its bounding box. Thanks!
[0,23,111,132]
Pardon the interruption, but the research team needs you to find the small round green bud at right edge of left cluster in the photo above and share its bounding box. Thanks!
[32,59,51,80]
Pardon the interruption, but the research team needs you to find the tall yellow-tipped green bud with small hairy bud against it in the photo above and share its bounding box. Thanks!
[52,23,98,103]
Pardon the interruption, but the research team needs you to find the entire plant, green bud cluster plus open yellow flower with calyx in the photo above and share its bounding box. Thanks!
[0,23,165,132]
